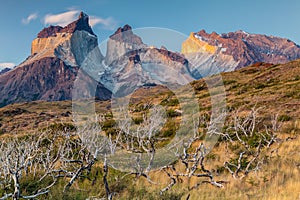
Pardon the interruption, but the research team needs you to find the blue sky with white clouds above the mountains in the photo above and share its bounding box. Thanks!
[0,0,300,67]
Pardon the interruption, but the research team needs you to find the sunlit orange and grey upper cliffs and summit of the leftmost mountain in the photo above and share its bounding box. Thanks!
[27,12,99,66]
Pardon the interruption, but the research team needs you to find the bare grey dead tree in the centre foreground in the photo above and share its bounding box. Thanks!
[118,106,165,184]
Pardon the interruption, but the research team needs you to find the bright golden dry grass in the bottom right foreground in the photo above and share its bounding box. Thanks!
[120,132,300,200]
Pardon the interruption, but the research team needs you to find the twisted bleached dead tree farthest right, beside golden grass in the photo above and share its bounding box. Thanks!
[224,107,280,179]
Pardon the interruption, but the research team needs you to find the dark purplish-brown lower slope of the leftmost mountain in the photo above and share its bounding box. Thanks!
[0,58,111,107]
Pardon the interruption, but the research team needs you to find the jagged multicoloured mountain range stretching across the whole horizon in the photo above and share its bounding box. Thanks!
[0,12,300,106]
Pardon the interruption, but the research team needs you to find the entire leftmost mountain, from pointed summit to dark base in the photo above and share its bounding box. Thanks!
[0,13,111,106]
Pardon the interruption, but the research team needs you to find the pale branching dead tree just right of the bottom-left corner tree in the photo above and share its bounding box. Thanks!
[41,123,115,199]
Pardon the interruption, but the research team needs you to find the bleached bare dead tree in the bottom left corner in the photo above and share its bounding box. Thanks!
[0,134,56,199]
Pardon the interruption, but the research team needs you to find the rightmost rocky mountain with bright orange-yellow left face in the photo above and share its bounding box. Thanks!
[182,30,300,75]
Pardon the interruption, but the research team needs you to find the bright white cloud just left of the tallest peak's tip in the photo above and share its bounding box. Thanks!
[44,10,80,26]
